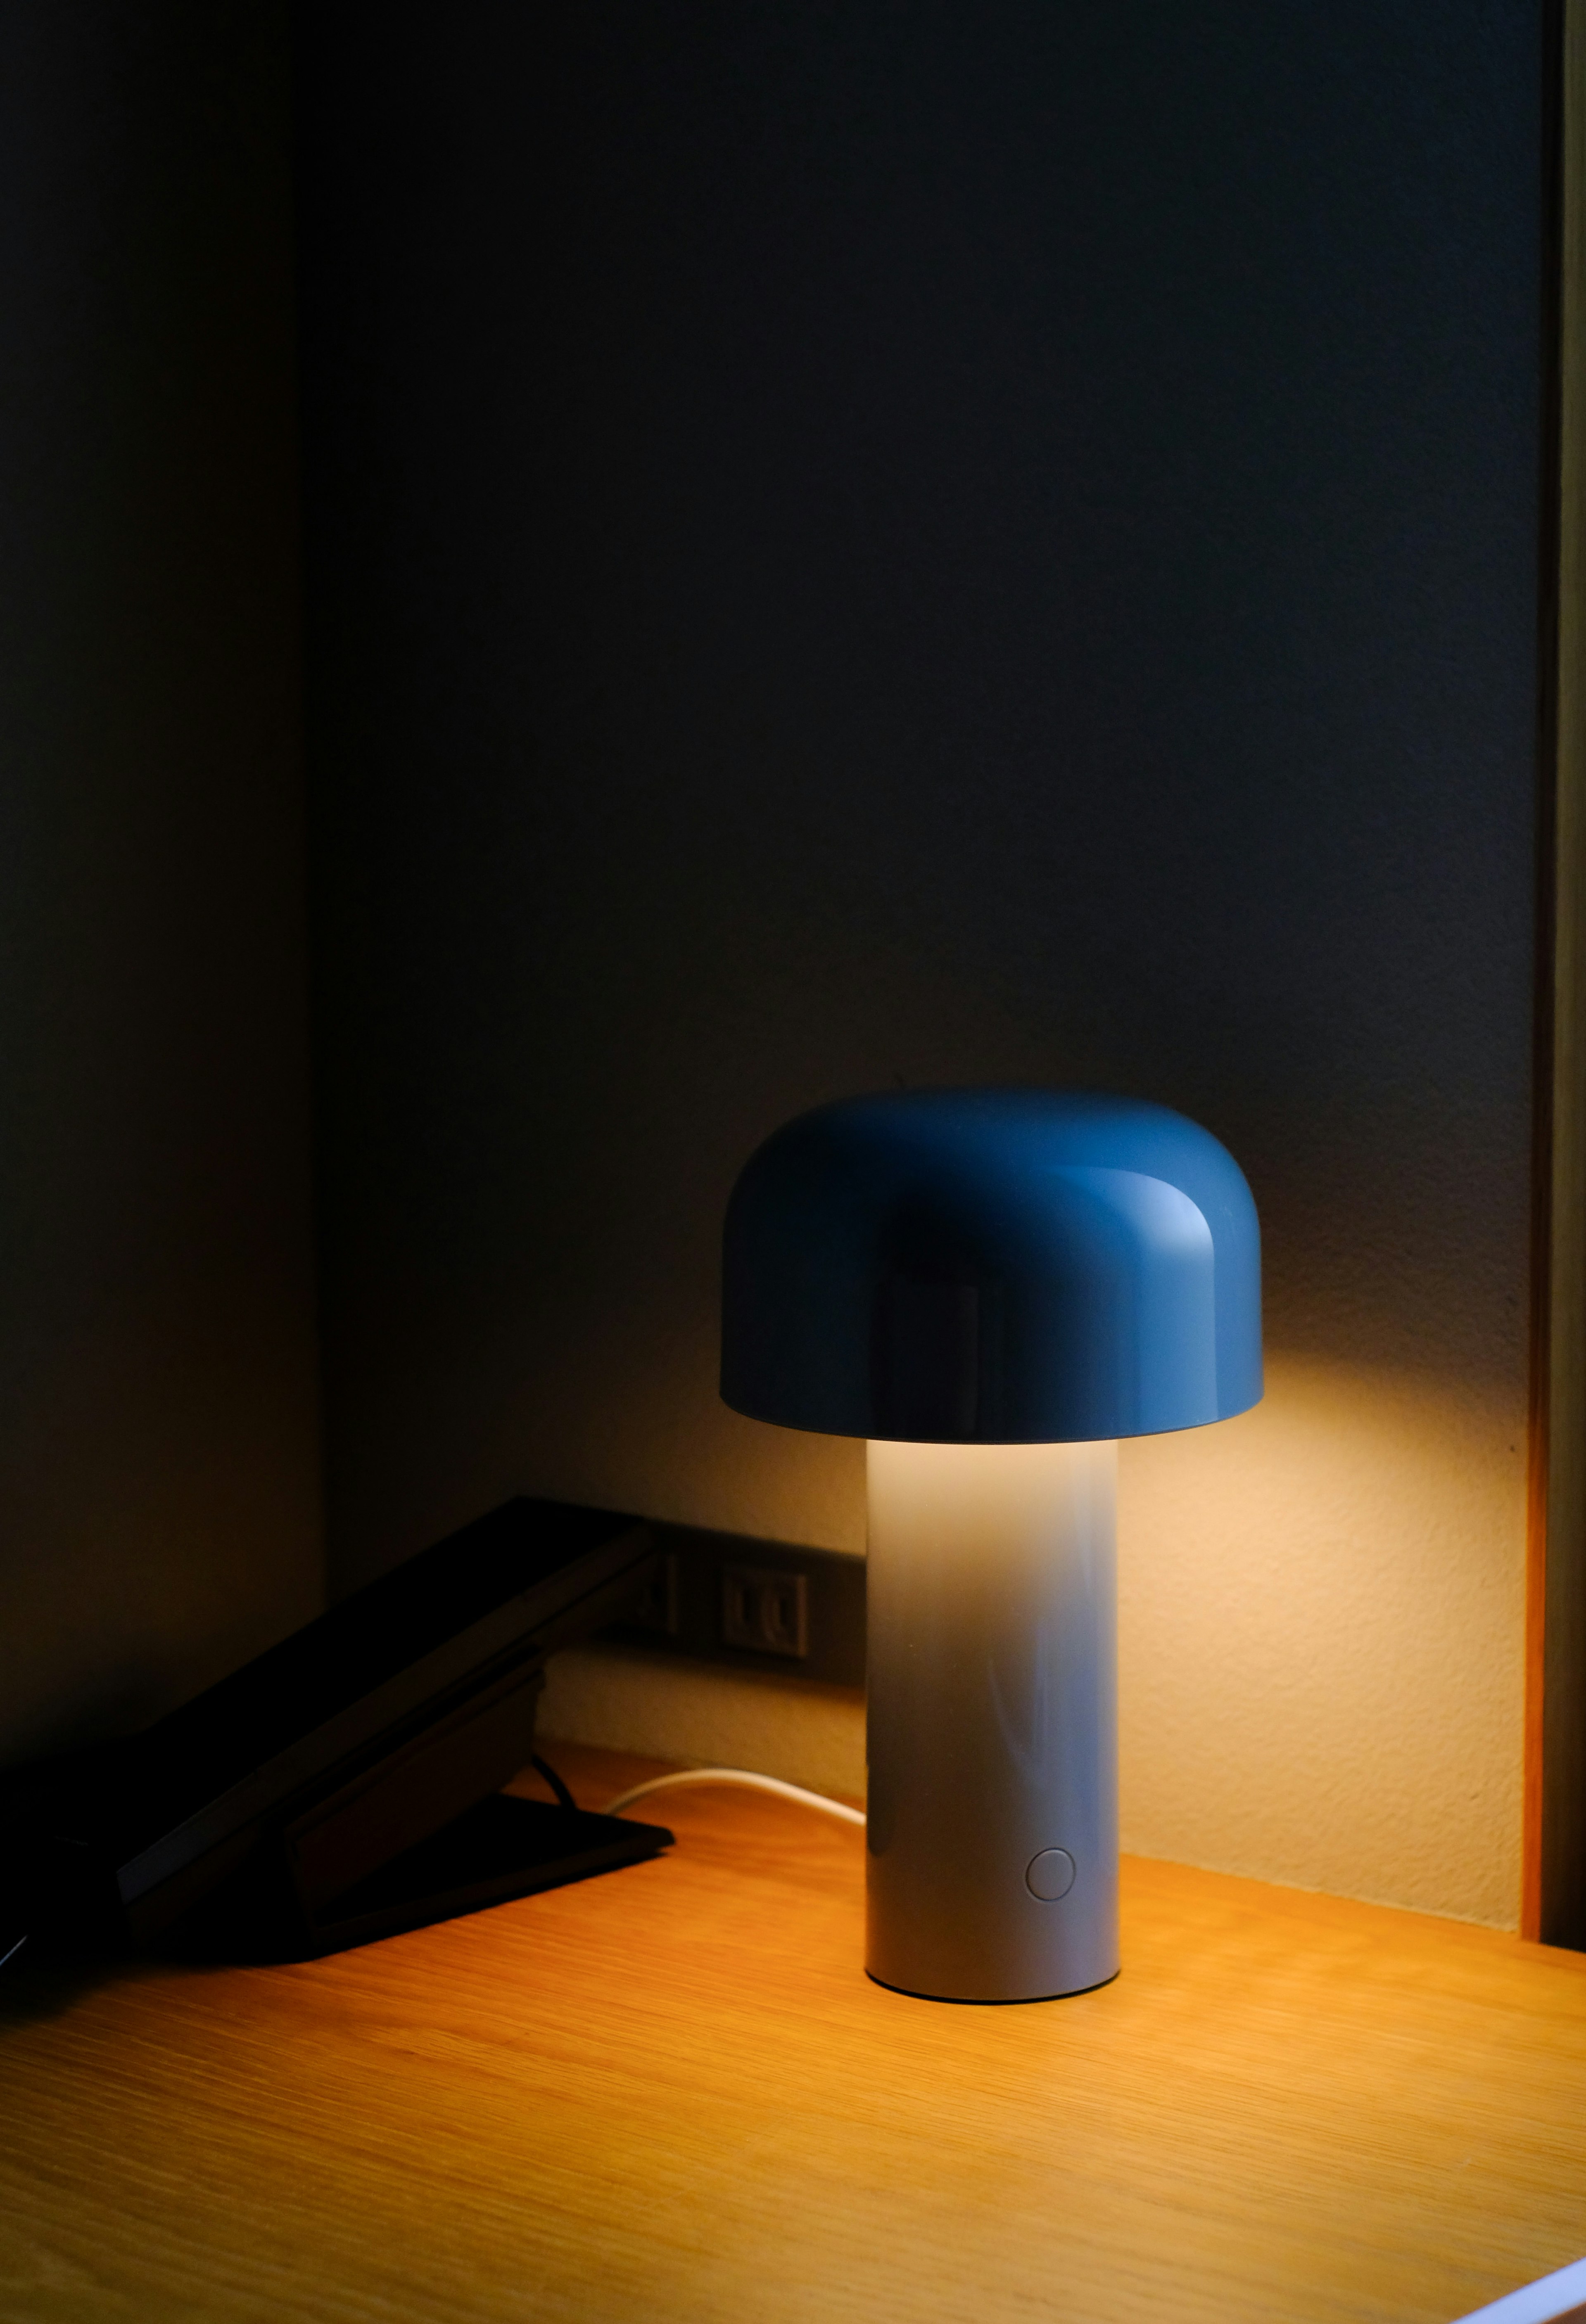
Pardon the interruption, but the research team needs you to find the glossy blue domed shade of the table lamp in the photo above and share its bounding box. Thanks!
[721,1090,1261,1443]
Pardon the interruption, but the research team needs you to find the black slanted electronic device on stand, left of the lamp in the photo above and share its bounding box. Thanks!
[0,1499,670,1959]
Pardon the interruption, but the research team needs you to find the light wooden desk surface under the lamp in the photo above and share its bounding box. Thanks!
[0,1748,1586,2324]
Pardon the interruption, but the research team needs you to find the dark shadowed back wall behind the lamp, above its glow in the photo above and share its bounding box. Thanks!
[298,0,1539,1578]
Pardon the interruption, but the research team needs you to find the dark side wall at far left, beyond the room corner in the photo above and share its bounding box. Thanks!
[0,0,321,1755]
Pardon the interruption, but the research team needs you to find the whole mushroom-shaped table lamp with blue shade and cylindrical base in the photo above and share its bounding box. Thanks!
[721,1090,1261,2001]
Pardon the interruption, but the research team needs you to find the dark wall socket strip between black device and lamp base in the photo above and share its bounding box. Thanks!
[602,1522,865,1687]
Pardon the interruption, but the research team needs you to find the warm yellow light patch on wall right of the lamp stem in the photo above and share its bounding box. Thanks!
[1118,1357,1526,1927]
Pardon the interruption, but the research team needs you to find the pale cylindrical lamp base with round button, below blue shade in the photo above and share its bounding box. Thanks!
[865,1441,1118,2001]
